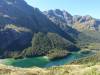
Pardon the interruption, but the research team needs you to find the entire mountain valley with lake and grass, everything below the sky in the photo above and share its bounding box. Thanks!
[0,0,100,75]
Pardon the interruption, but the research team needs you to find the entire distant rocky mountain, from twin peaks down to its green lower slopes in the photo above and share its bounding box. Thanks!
[43,9,100,48]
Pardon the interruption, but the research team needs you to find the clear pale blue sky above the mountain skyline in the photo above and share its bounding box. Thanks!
[25,0,100,19]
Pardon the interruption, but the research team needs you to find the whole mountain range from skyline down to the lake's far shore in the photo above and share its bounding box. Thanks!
[0,0,100,58]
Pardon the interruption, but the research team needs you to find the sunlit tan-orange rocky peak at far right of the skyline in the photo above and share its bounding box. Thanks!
[73,15,100,31]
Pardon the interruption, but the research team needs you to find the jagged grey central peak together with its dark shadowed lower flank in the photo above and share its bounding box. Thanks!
[44,9,78,35]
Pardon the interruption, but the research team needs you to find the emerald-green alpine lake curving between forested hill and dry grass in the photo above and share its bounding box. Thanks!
[0,52,94,68]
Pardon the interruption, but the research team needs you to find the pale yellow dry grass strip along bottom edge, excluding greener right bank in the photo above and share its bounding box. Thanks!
[0,65,100,75]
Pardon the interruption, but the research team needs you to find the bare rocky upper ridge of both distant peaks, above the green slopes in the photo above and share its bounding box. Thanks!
[44,9,100,31]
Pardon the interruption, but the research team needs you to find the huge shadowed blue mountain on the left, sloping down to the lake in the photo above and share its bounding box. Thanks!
[0,0,77,57]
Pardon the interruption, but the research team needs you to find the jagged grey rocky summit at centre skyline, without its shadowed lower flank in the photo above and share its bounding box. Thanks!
[44,9,73,25]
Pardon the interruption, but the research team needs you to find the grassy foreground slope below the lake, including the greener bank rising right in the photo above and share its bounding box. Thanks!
[0,52,100,75]
